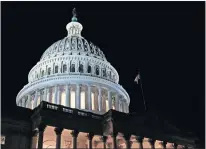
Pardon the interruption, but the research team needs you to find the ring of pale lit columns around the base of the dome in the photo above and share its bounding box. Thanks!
[19,84,129,113]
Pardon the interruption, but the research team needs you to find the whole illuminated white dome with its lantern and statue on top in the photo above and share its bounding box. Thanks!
[16,11,130,114]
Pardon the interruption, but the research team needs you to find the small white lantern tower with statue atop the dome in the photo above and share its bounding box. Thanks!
[66,8,83,36]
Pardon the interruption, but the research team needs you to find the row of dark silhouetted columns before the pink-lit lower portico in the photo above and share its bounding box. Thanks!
[35,126,188,149]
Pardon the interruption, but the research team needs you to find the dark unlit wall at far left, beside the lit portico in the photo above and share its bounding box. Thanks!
[1,108,32,149]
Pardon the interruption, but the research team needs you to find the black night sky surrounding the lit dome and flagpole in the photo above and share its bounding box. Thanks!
[1,2,205,142]
